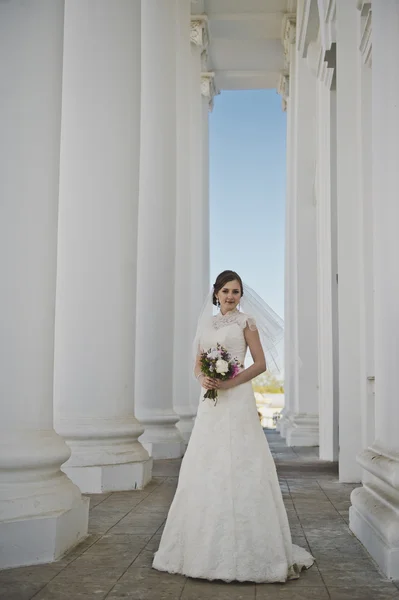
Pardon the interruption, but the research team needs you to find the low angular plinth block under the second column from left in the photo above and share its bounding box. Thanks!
[62,458,153,494]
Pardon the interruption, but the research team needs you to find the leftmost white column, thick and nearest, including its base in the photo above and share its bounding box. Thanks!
[0,0,88,568]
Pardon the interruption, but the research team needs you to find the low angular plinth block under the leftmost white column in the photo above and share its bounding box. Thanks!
[0,498,90,569]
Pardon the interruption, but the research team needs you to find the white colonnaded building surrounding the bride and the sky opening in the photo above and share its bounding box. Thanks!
[0,0,399,579]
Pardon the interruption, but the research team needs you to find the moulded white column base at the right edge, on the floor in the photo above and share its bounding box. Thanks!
[349,448,399,579]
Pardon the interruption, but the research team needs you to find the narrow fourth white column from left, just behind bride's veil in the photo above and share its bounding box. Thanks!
[173,0,199,443]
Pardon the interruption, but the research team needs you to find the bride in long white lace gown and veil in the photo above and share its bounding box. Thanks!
[153,271,313,583]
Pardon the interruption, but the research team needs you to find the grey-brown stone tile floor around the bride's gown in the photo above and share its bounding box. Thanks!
[0,432,399,600]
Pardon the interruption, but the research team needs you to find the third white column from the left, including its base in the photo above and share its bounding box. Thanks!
[135,0,184,458]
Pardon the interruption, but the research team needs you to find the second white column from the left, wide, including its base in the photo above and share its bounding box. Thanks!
[55,0,151,493]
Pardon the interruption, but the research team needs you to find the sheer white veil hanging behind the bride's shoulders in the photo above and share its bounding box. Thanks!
[193,283,284,375]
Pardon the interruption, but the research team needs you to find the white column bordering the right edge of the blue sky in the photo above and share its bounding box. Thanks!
[286,55,319,446]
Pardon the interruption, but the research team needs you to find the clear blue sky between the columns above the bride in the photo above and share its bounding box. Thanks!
[210,90,286,317]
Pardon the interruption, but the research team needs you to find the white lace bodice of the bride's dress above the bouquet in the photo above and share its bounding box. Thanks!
[200,310,256,363]
